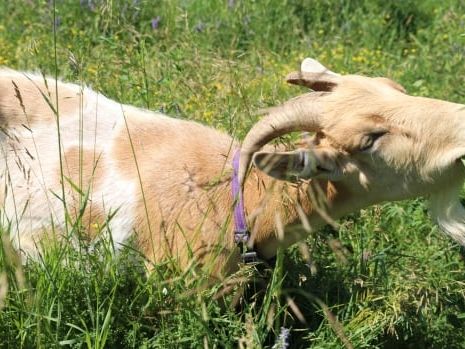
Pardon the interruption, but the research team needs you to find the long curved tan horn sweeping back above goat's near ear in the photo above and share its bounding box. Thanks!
[238,92,327,184]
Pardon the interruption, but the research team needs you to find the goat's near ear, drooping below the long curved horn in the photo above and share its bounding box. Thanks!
[252,150,340,181]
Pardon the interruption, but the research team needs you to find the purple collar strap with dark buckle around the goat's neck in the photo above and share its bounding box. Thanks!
[231,149,257,264]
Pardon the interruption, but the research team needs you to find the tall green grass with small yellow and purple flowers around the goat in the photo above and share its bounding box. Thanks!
[0,0,465,348]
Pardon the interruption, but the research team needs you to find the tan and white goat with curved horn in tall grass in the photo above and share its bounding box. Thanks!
[0,60,465,272]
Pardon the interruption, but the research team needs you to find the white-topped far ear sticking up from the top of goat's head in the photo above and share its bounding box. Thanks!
[286,58,340,91]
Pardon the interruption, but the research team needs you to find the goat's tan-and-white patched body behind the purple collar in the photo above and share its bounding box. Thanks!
[0,70,316,274]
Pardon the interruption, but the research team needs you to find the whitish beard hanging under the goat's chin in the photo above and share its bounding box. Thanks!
[430,184,465,246]
